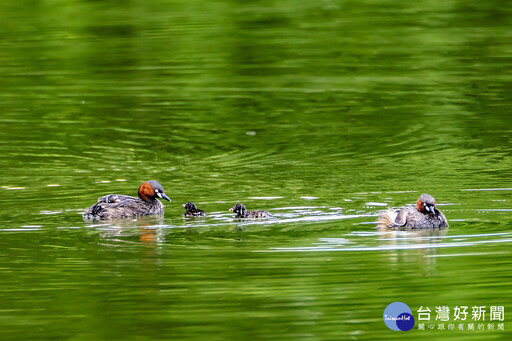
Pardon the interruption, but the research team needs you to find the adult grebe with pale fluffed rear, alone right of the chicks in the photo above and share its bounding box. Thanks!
[377,194,448,230]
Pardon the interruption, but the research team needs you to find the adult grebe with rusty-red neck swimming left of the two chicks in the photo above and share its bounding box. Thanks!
[83,180,171,220]
